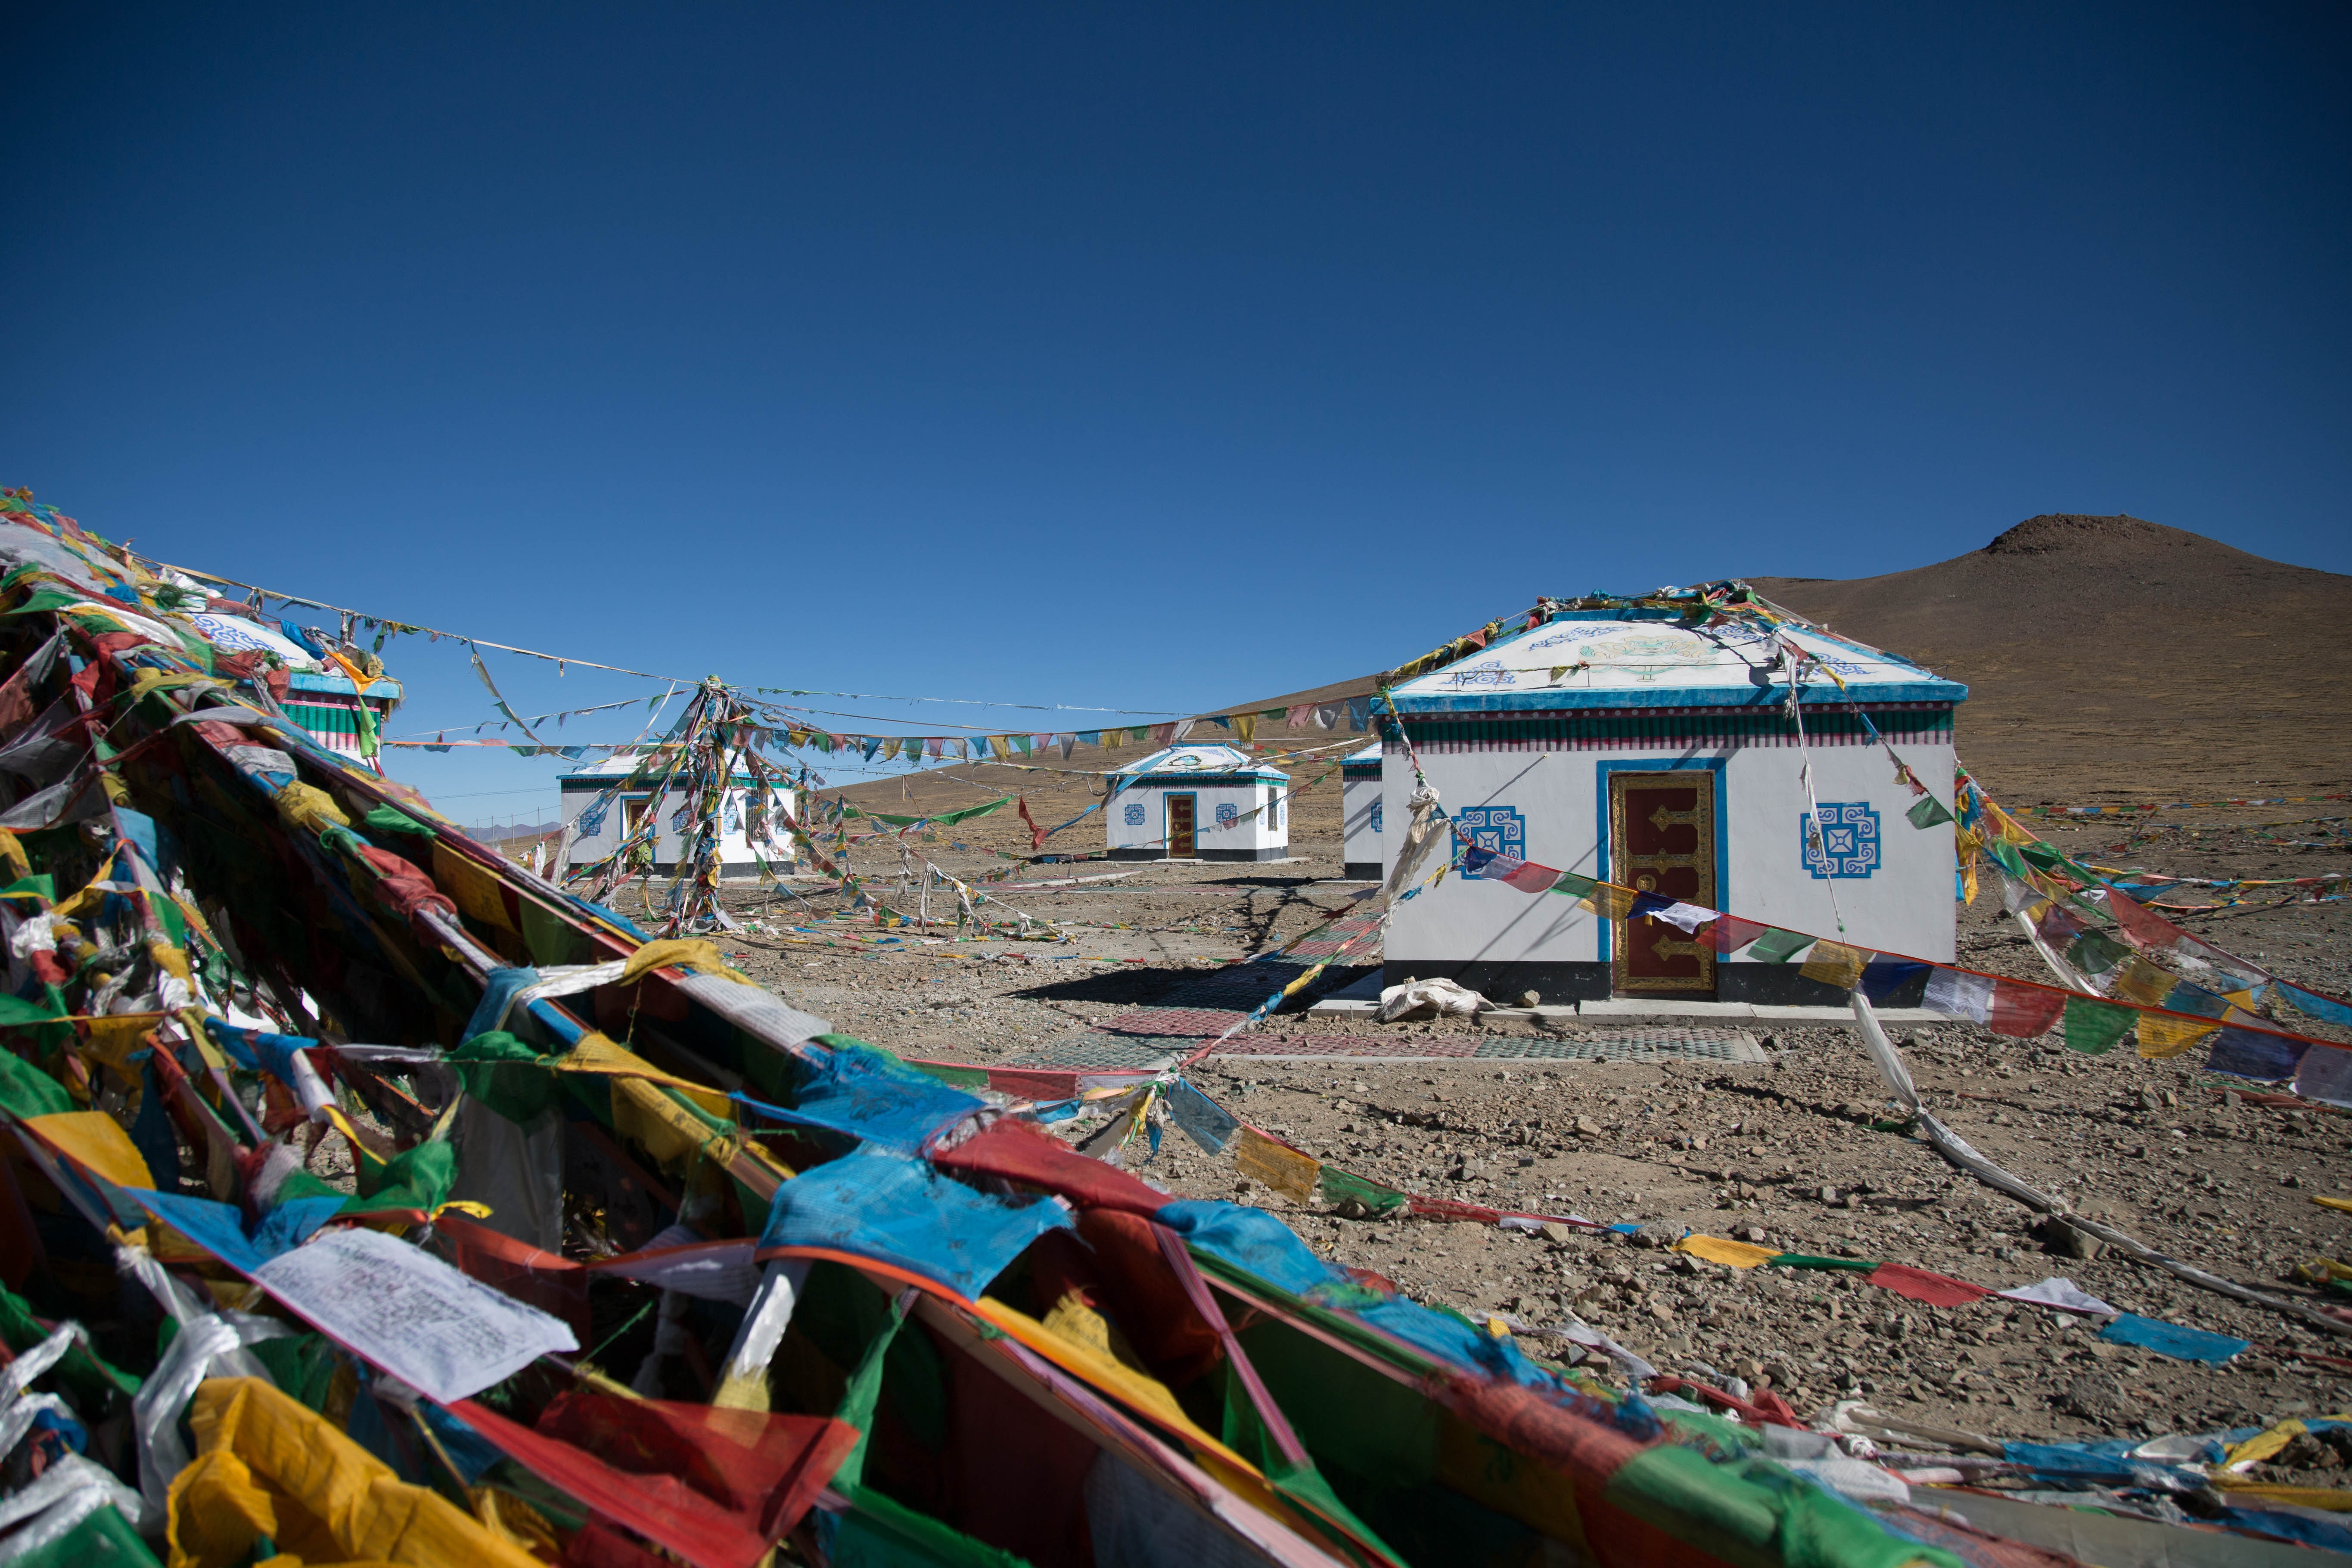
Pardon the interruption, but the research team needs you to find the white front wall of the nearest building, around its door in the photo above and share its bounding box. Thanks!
[1381,743,1954,964]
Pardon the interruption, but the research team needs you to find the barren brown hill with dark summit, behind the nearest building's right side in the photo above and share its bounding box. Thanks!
[1750,512,2352,804]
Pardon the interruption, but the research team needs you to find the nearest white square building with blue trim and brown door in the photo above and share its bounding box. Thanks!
[1350,606,1969,1004]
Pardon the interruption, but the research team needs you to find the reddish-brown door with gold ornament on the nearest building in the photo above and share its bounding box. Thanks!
[1609,771,1715,997]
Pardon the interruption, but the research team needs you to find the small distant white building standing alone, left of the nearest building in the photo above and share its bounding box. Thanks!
[1103,745,1291,860]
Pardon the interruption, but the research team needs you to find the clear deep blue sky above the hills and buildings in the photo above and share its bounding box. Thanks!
[0,5,2352,818]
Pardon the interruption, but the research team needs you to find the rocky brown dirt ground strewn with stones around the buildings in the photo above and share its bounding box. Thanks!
[668,804,2352,1479]
